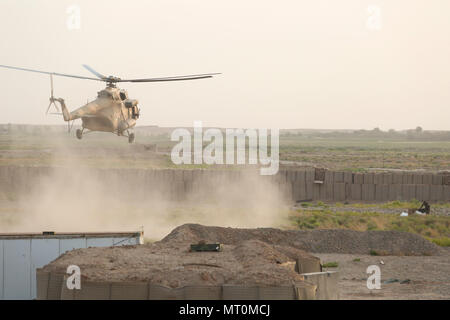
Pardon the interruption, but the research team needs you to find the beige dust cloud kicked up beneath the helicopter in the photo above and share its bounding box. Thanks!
[5,137,287,240]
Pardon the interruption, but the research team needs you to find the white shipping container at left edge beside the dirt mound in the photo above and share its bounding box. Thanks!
[0,232,143,300]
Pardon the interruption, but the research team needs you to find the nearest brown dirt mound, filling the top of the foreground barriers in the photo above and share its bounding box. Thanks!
[44,239,318,288]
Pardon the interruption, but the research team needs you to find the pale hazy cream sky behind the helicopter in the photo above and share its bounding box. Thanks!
[0,0,450,130]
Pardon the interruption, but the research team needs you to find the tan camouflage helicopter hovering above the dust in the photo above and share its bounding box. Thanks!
[0,64,220,143]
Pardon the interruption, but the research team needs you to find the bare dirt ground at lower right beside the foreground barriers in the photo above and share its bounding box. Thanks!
[314,250,450,300]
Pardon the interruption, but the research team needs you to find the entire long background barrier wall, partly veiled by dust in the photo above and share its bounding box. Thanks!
[0,166,450,202]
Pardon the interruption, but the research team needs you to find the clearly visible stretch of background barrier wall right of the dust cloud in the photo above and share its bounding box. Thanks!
[281,169,450,201]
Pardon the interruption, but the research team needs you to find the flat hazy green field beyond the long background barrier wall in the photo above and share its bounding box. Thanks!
[0,127,450,172]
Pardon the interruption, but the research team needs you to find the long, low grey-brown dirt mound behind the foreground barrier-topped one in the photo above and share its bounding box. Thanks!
[161,224,442,256]
